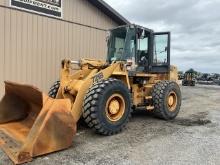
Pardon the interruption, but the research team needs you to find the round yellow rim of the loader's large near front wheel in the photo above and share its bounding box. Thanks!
[105,94,125,122]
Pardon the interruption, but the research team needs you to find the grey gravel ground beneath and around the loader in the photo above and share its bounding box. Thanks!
[0,85,220,165]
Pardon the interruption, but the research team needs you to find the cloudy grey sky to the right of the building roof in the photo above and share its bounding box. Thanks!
[105,0,220,73]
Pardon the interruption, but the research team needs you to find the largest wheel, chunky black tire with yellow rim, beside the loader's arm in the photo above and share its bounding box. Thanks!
[83,78,132,135]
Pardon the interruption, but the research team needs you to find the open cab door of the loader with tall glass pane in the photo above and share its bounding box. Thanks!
[150,32,170,73]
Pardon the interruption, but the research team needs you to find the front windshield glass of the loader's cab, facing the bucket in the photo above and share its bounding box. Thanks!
[108,27,135,62]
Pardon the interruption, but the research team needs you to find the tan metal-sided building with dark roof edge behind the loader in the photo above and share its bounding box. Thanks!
[0,0,129,96]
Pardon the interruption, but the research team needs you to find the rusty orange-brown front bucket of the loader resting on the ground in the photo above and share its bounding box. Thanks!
[0,82,76,164]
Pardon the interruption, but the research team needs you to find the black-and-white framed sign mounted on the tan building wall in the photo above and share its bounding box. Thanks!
[10,0,62,18]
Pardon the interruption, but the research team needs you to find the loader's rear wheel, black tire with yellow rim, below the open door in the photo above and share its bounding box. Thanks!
[152,81,182,120]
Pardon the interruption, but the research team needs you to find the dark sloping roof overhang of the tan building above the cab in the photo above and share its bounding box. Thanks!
[88,0,130,25]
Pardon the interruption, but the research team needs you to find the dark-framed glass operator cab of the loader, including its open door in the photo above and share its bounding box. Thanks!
[107,24,170,73]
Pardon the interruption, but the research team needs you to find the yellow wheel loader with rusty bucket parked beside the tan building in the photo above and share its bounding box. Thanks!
[0,24,181,164]
